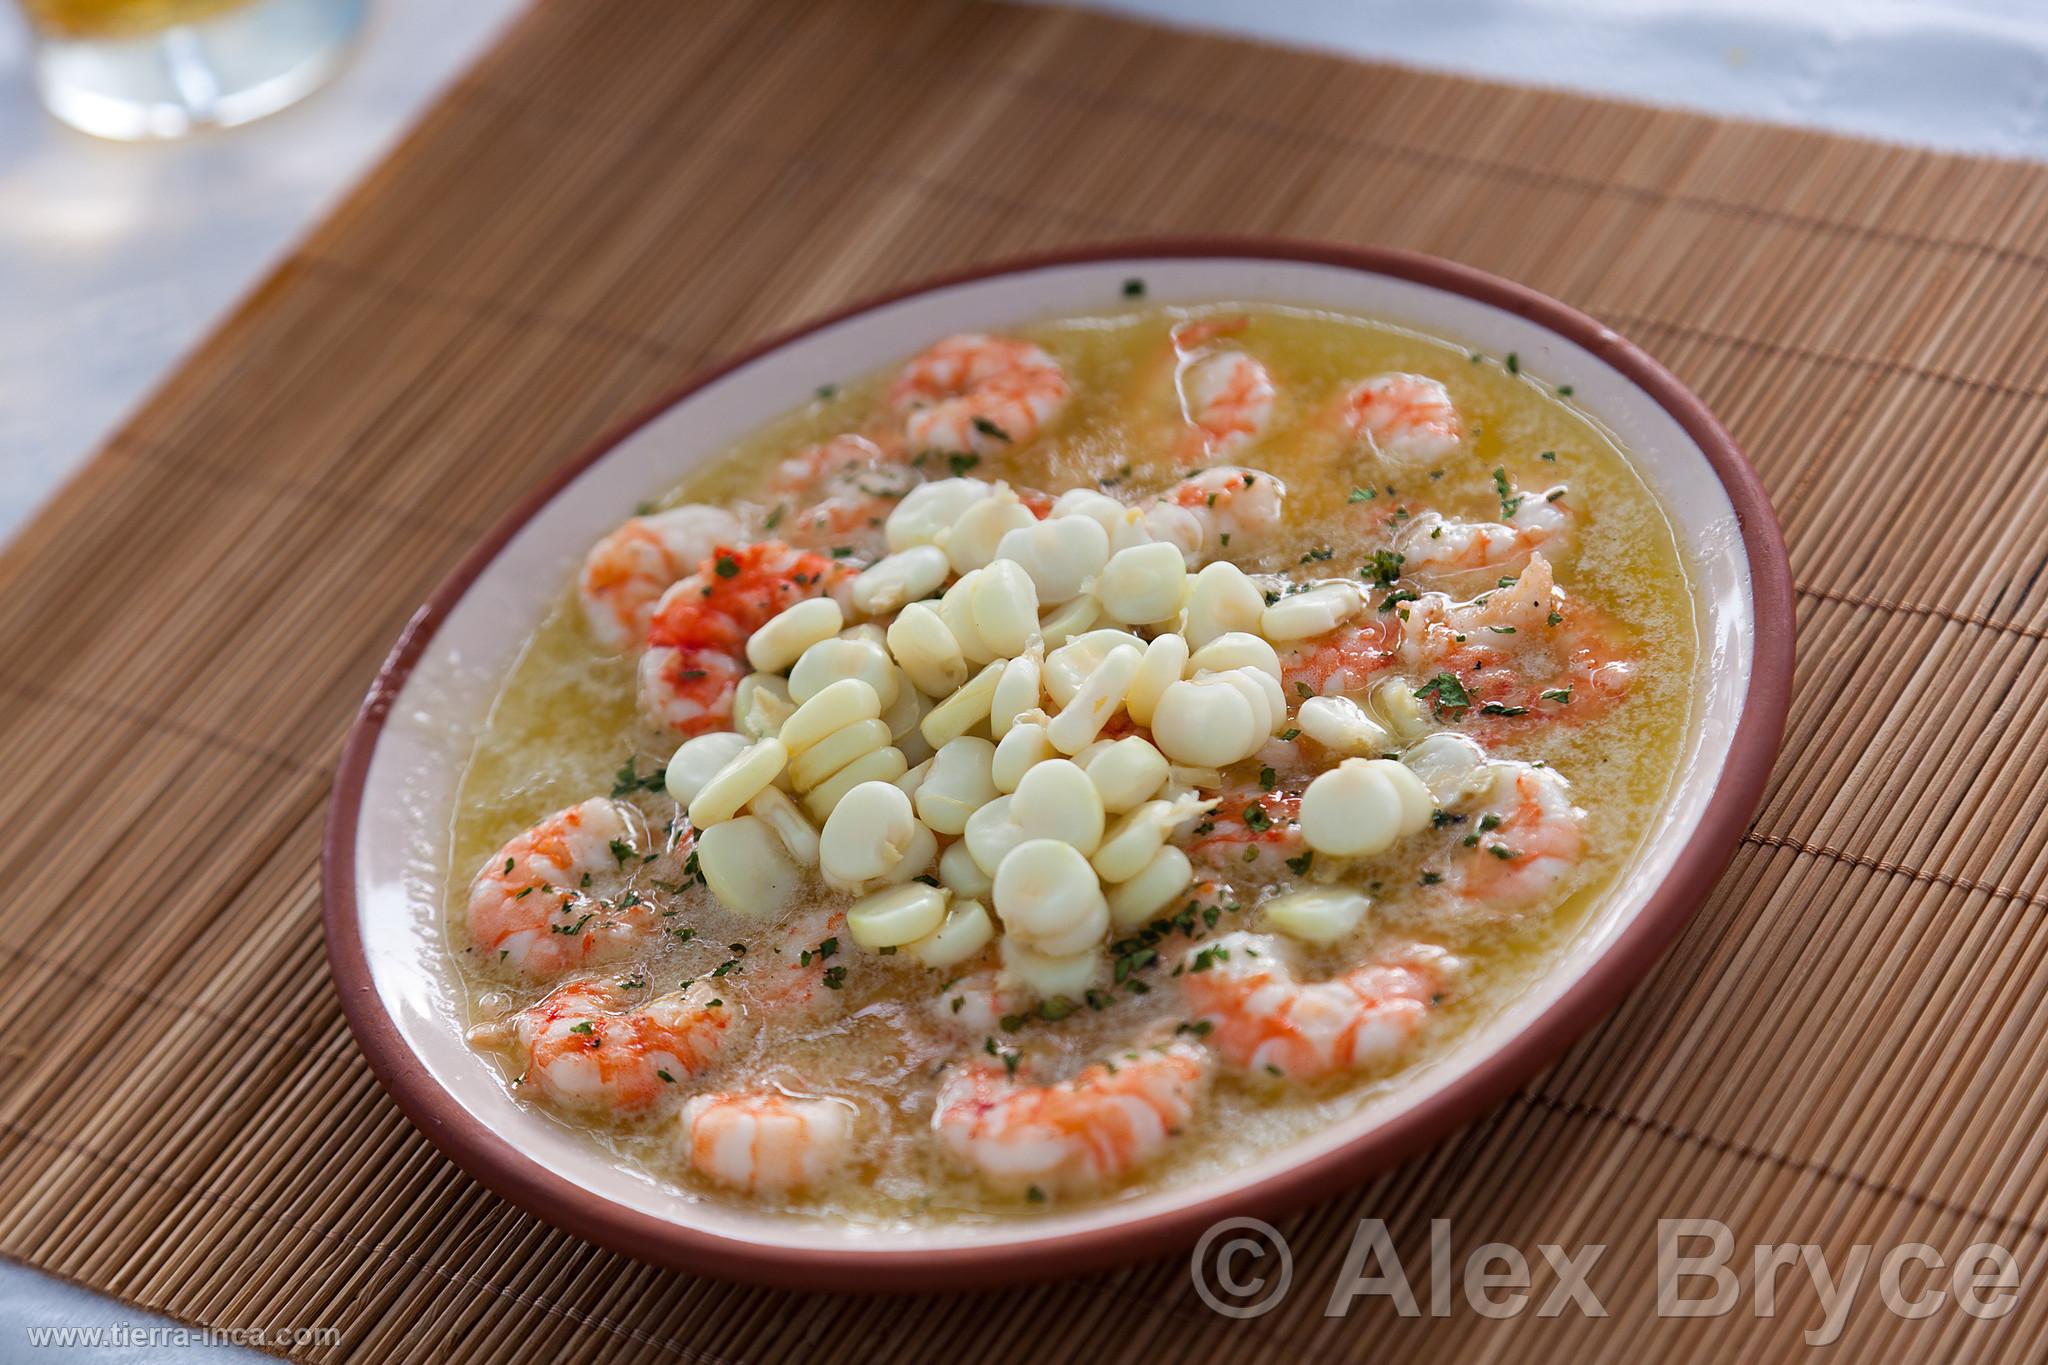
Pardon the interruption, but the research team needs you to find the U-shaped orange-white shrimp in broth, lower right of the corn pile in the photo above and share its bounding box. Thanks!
[1180,931,1458,1081]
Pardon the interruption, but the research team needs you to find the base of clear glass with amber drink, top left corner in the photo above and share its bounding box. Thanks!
[23,0,367,139]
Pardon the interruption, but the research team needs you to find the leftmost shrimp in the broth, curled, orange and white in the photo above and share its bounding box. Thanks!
[469,796,651,980]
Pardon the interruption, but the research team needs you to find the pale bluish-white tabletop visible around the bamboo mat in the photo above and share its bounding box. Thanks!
[0,0,2048,1361]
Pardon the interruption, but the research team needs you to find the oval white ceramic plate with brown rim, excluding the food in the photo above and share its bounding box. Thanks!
[324,241,1792,1289]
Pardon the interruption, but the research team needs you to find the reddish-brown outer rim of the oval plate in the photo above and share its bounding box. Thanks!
[322,237,1794,1291]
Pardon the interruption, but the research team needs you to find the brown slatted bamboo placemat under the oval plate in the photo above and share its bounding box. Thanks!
[0,0,2048,1365]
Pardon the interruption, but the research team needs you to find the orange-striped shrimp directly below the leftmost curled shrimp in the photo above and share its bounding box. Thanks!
[491,980,739,1115]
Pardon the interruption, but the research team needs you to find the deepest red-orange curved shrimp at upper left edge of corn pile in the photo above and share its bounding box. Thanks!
[639,540,850,735]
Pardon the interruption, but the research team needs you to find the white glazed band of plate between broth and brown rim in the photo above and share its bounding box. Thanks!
[344,258,1753,1254]
